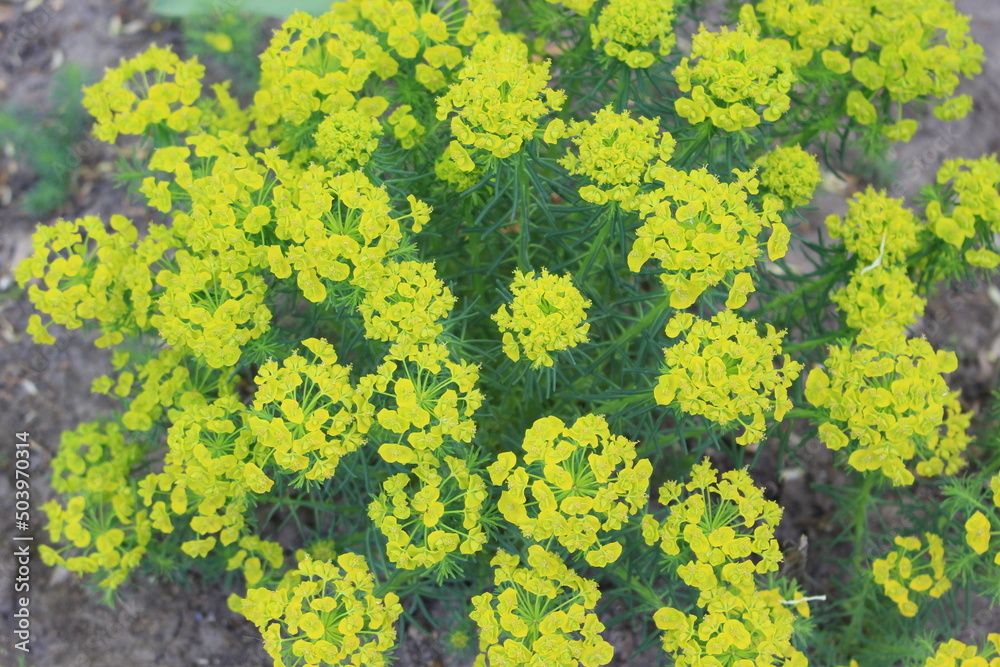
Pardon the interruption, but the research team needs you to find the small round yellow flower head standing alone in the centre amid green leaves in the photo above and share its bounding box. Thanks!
[493,269,590,368]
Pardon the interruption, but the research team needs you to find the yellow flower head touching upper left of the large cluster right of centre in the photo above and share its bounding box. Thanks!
[560,106,676,204]
